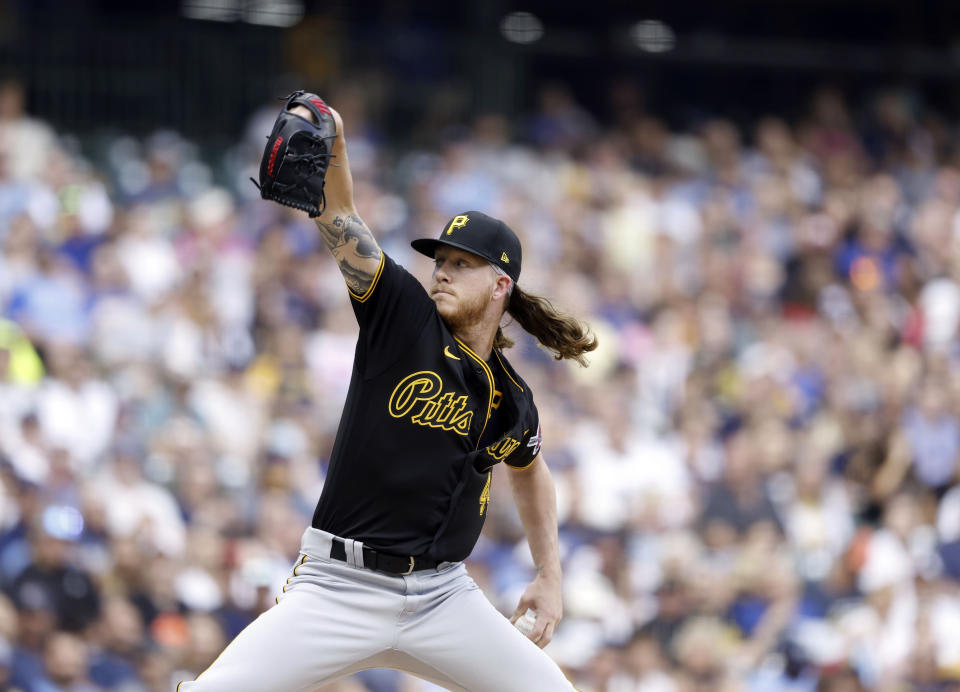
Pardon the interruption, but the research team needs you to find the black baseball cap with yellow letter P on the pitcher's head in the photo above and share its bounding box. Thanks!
[410,211,523,283]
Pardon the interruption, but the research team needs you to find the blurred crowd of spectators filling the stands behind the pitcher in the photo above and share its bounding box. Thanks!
[0,71,960,692]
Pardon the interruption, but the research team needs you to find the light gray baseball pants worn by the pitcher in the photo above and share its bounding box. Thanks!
[177,528,574,692]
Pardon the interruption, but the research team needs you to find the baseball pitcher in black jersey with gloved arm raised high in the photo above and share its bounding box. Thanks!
[177,92,596,692]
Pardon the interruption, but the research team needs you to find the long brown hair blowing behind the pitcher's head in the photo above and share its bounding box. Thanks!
[493,285,597,367]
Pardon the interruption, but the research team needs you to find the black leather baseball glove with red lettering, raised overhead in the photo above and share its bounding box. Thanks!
[251,91,337,218]
